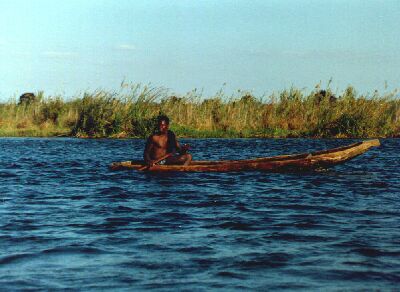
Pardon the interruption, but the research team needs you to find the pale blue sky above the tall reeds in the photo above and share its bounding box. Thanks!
[0,0,400,100]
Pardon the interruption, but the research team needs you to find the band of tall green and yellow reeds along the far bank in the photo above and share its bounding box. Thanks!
[0,84,400,138]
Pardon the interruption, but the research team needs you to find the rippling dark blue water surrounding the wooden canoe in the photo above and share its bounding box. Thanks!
[0,138,400,291]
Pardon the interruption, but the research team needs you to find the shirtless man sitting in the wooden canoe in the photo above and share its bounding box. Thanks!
[143,116,192,167]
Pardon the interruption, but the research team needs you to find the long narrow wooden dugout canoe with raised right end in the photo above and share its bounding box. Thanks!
[110,139,380,172]
